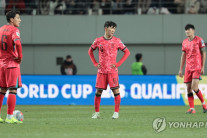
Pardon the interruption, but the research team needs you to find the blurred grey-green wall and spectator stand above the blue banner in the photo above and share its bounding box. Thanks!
[0,0,207,75]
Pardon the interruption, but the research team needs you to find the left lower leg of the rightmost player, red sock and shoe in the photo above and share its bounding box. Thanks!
[186,82,195,114]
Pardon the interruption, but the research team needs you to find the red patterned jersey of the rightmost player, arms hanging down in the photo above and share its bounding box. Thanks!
[182,36,205,71]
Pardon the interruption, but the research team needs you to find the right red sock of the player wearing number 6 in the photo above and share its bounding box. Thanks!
[7,93,16,115]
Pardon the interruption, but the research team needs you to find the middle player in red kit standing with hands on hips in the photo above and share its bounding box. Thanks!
[88,21,130,119]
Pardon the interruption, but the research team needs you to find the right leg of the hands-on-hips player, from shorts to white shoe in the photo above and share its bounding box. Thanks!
[108,73,121,119]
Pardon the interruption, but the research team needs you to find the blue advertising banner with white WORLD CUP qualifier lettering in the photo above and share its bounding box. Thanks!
[4,75,185,105]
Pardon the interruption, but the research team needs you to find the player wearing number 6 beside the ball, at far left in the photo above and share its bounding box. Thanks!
[0,11,22,123]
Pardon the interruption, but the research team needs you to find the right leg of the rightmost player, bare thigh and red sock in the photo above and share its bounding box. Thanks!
[191,79,207,113]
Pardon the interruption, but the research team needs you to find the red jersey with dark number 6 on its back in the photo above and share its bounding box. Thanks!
[0,25,20,67]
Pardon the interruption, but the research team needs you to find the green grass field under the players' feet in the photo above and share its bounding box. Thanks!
[0,105,207,138]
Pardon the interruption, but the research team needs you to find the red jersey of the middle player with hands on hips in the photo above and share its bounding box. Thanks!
[91,36,126,73]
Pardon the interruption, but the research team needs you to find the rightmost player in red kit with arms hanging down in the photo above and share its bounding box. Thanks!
[179,24,207,114]
